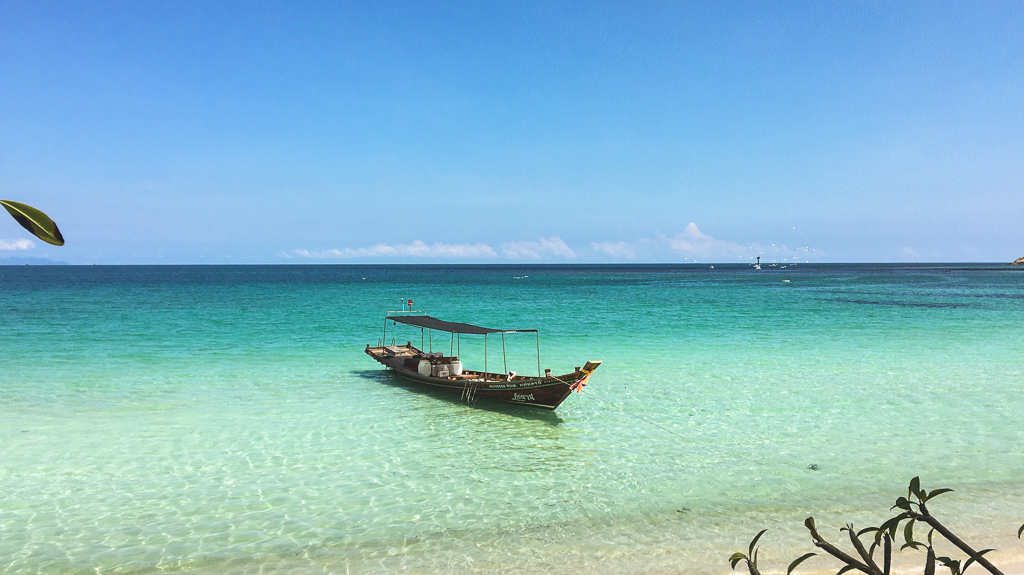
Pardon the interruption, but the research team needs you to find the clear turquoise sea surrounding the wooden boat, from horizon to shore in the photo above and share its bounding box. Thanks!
[0,264,1024,574]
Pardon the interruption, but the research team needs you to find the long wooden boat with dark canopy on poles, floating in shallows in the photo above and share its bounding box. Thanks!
[366,308,601,409]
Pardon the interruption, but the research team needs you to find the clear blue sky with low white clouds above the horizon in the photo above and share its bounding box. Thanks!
[0,0,1024,264]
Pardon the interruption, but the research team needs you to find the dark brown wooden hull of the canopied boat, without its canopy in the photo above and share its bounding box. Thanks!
[366,346,600,409]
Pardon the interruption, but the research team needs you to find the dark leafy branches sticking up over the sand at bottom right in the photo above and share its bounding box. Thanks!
[729,477,1024,575]
